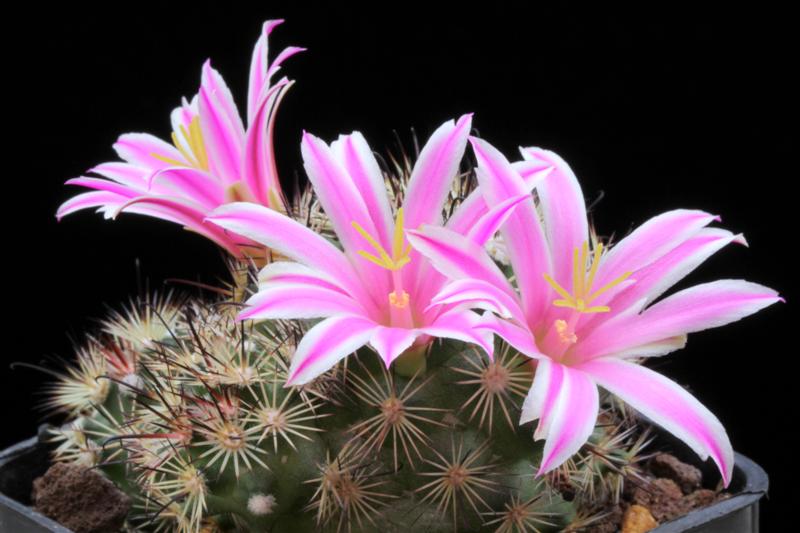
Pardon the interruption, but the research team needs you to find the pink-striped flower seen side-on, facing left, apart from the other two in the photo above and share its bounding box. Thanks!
[56,20,303,256]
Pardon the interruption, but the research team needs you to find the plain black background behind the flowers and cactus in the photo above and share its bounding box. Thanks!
[0,2,798,531]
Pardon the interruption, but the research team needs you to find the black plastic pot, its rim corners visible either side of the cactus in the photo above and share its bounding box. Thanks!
[0,430,769,533]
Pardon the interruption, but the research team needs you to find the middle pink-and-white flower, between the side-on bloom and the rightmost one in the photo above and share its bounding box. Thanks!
[208,115,530,385]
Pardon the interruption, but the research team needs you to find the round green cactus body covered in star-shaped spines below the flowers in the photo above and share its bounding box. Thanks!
[40,276,647,532]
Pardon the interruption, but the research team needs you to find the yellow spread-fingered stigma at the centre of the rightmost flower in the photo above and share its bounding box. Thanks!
[544,242,631,312]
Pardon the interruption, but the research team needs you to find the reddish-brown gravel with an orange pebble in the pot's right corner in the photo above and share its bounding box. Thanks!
[587,453,729,533]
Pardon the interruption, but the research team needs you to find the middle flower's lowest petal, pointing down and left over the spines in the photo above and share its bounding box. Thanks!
[286,316,376,386]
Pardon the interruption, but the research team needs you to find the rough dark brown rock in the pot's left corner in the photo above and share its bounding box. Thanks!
[33,463,130,533]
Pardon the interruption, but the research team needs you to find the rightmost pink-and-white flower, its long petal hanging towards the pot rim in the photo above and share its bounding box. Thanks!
[408,139,781,485]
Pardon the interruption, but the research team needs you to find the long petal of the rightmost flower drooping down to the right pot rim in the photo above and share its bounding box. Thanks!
[580,359,733,486]
